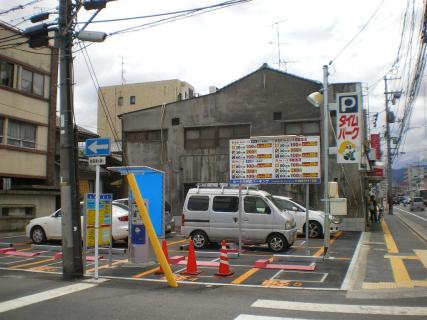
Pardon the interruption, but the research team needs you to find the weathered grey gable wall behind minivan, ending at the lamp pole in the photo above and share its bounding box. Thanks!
[122,68,320,218]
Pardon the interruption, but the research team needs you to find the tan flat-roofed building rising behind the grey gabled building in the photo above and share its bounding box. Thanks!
[98,80,194,140]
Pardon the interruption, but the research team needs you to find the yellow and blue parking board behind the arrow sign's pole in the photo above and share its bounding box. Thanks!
[85,193,113,247]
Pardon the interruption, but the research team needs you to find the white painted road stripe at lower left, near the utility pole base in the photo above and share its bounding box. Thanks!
[0,282,97,313]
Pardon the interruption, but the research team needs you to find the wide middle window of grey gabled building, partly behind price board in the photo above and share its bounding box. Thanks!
[185,125,250,149]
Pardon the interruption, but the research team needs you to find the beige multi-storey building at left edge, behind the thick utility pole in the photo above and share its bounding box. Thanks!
[0,23,59,231]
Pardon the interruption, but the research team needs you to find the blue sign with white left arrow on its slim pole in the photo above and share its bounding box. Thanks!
[84,138,111,279]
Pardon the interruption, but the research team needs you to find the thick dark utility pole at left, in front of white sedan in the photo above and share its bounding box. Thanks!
[58,0,83,280]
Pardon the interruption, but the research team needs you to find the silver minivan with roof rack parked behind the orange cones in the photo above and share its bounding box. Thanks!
[181,187,297,252]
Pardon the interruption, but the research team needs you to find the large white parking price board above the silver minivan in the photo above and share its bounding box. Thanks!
[230,136,320,184]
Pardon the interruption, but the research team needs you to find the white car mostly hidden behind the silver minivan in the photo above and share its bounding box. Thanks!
[273,196,341,238]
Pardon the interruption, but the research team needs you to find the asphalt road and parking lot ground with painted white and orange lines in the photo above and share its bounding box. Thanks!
[0,208,427,320]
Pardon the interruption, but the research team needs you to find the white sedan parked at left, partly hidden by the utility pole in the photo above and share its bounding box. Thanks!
[25,204,129,244]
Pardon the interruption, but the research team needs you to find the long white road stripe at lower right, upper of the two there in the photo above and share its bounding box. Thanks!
[251,299,427,316]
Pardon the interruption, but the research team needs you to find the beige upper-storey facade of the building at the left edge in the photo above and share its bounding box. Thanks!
[0,24,57,184]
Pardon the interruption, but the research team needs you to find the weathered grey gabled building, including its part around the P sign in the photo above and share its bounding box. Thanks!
[121,66,365,230]
